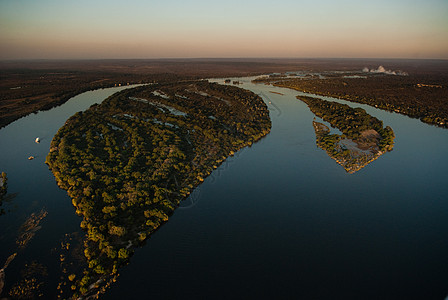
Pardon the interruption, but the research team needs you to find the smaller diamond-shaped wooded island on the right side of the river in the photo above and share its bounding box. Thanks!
[297,96,395,173]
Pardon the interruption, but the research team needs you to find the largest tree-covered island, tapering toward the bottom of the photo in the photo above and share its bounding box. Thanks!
[46,81,271,297]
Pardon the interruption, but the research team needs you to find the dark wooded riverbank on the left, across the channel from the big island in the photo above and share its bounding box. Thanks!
[0,70,191,128]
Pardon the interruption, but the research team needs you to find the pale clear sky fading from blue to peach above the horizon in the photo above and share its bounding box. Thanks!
[0,0,448,60]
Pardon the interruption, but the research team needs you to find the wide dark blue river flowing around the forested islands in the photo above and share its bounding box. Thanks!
[0,78,448,299]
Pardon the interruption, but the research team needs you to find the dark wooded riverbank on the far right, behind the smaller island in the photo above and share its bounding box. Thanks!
[275,74,448,128]
